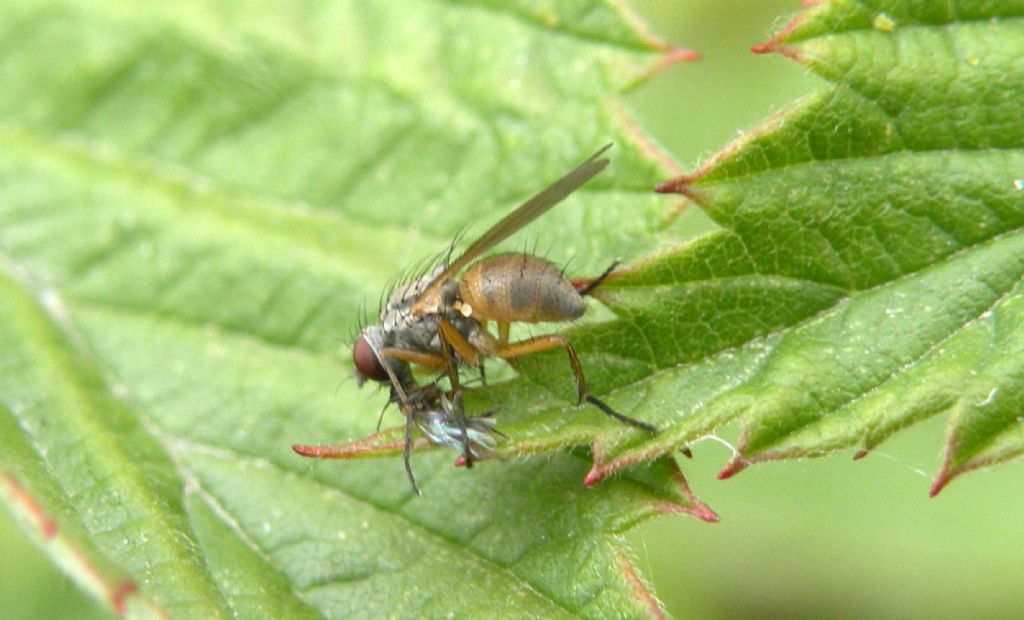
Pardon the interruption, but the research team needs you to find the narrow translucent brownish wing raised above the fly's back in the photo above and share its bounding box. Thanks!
[413,143,611,311]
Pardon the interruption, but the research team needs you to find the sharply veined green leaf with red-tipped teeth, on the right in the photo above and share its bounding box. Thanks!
[448,2,1024,494]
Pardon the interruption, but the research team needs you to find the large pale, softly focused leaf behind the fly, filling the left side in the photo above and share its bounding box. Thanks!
[0,0,713,618]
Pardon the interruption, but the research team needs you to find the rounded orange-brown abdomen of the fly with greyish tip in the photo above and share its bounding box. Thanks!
[459,254,587,323]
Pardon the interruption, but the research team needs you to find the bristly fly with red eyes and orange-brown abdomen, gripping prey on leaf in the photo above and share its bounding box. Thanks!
[299,144,656,489]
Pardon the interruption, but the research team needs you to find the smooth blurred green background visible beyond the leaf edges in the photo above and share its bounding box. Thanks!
[0,0,1024,619]
